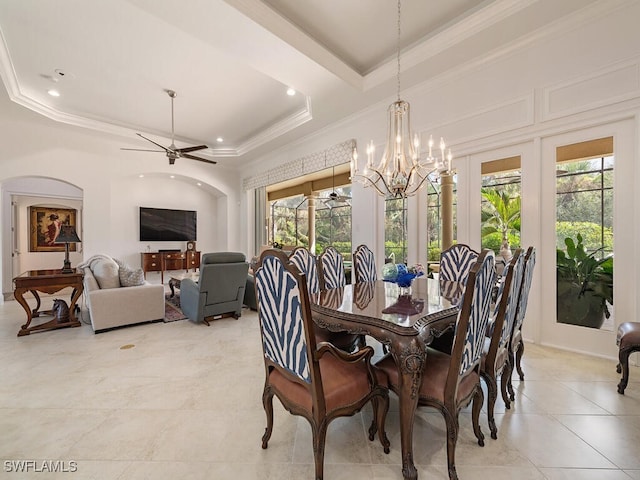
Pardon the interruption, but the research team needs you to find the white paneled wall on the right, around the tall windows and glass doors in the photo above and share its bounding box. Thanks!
[243,0,640,357]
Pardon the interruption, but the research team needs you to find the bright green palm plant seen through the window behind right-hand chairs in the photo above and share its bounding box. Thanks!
[481,188,520,255]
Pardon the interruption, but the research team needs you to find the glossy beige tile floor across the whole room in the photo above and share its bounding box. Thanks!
[0,299,640,480]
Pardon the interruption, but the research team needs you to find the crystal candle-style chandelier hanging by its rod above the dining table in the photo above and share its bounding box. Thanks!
[351,0,452,198]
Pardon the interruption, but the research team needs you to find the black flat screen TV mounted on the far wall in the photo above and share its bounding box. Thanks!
[140,207,198,242]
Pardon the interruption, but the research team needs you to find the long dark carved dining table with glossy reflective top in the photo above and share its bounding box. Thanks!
[310,277,464,480]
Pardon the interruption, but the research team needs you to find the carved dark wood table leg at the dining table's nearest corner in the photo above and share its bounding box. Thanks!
[393,337,426,480]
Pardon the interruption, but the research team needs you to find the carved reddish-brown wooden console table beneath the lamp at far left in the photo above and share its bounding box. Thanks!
[13,270,83,337]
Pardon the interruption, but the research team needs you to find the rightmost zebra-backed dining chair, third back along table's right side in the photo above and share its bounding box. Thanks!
[503,246,536,400]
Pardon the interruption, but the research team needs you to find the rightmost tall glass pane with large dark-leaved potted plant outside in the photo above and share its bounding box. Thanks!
[556,137,615,331]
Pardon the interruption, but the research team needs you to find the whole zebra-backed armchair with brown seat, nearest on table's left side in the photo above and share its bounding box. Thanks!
[255,250,390,480]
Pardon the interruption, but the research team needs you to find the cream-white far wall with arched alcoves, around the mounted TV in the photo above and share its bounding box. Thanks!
[0,94,246,297]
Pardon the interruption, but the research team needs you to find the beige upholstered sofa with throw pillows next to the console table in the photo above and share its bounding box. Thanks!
[79,255,164,333]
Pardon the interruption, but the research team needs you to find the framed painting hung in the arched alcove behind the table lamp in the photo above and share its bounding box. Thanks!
[29,207,76,252]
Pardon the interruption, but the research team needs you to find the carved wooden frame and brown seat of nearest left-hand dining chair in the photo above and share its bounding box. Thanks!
[255,250,390,480]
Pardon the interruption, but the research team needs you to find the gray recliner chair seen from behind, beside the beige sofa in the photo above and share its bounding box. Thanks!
[180,252,249,325]
